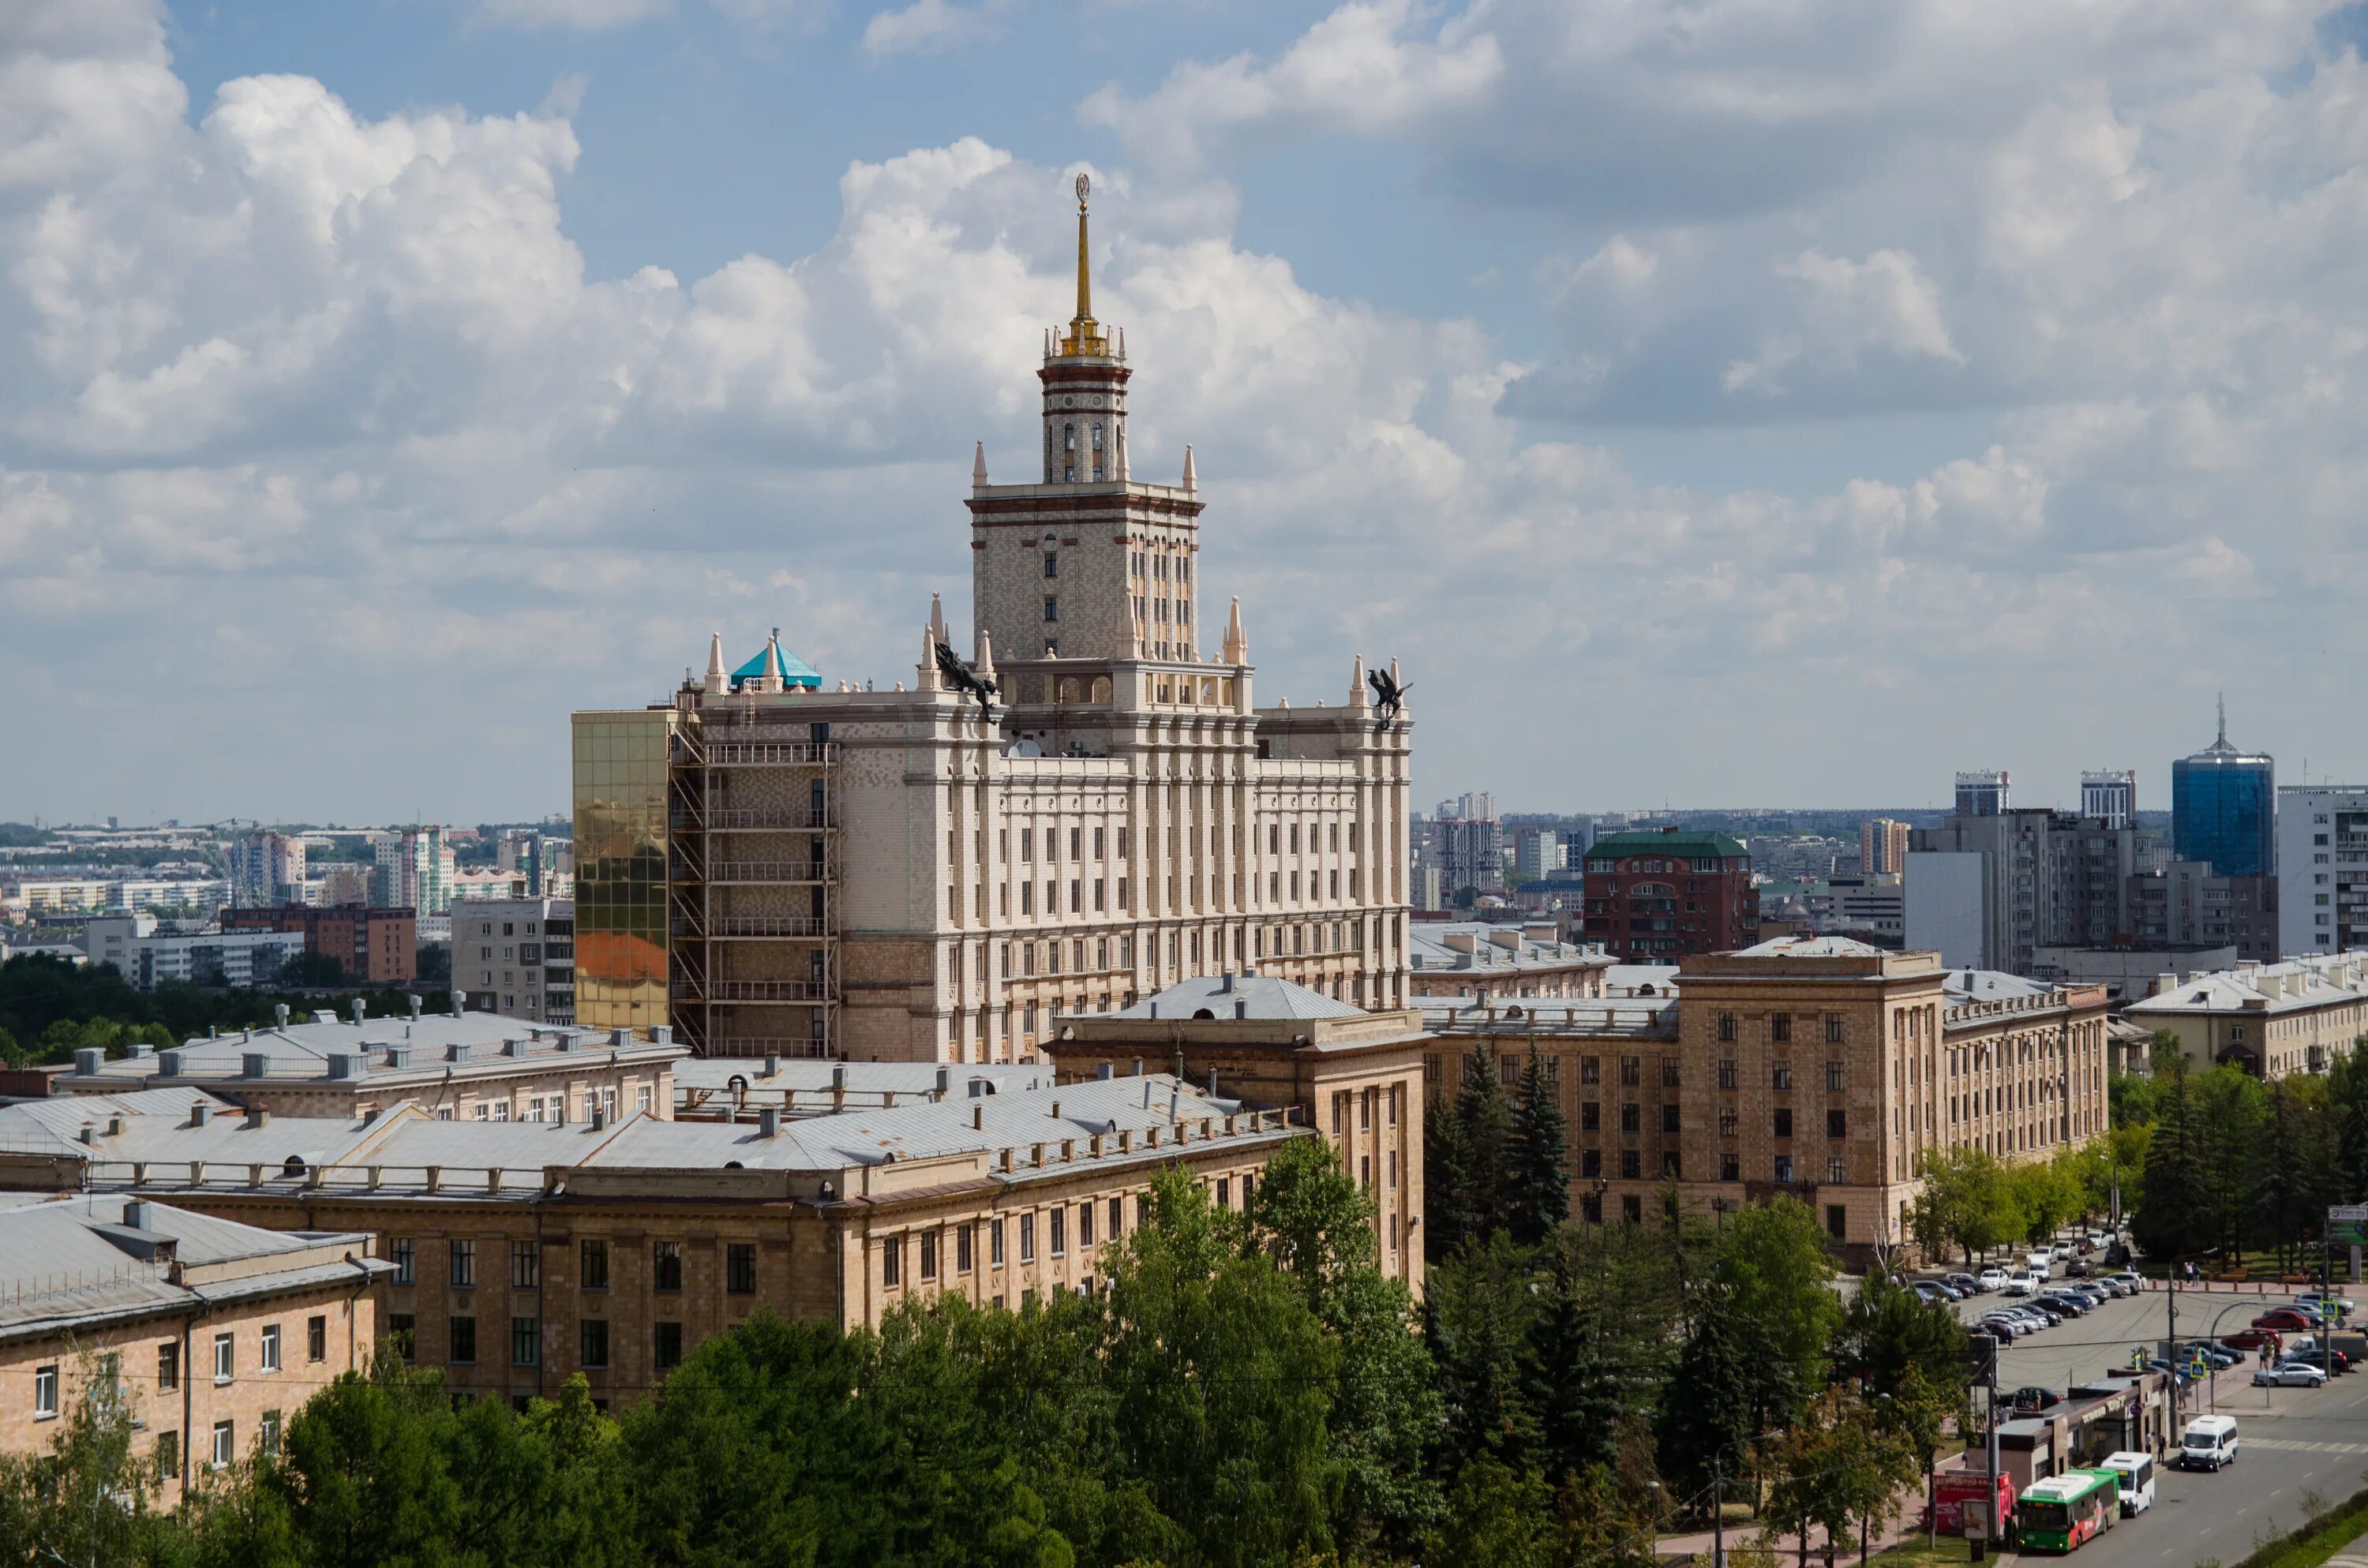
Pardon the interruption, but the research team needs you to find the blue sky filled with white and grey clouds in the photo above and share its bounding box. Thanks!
[0,0,2368,822]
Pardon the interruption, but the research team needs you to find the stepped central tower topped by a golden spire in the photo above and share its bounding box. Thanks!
[969,175,1201,677]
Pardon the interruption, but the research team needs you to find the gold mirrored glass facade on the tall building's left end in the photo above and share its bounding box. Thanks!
[575,708,675,1031]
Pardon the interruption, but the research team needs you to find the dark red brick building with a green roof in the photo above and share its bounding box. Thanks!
[1584,827,1759,960]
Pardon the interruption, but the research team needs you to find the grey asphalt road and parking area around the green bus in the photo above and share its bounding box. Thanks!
[1958,1291,2368,1568]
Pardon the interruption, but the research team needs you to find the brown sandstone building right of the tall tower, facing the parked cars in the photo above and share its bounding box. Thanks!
[1423,938,2110,1258]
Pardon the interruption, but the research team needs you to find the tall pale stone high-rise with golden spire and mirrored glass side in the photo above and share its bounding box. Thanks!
[575,180,1411,1061]
